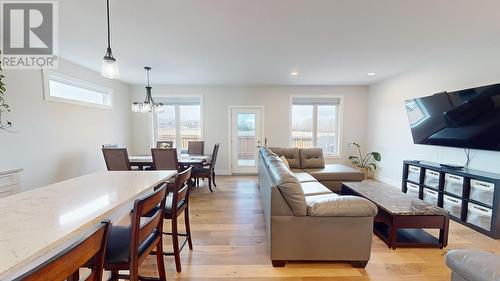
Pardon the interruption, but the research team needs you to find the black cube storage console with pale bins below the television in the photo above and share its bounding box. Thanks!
[402,160,500,239]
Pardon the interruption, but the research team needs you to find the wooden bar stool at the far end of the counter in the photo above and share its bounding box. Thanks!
[163,167,193,272]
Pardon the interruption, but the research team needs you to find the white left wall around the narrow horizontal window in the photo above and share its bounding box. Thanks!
[0,60,130,189]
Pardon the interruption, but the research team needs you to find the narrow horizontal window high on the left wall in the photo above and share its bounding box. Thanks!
[44,72,113,108]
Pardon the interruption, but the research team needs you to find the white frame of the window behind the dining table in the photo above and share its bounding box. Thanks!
[150,94,205,147]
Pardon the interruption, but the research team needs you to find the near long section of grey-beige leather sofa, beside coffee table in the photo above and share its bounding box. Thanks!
[259,148,377,267]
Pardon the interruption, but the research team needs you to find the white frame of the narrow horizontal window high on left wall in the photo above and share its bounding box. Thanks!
[42,70,114,109]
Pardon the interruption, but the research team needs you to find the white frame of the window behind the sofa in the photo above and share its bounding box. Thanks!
[288,95,344,159]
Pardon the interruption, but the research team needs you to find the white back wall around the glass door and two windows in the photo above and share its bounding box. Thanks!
[132,86,367,174]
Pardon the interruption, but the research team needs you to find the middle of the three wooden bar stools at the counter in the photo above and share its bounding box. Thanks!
[104,184,167,281]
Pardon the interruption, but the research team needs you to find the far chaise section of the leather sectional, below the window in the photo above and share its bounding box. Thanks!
[269,147,365,190]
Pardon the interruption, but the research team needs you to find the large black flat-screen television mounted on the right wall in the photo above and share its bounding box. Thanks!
[406,84,500,151]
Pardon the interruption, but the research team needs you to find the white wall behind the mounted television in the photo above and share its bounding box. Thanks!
[367,44,500,186]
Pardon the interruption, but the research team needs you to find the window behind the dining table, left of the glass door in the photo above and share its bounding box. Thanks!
[154,97,203,149]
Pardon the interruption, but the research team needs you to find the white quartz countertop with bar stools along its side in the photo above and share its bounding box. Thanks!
[0,171,176,280]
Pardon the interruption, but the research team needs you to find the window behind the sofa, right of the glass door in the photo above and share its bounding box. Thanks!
[291,97,341,156]
